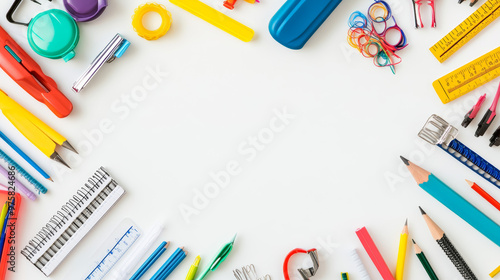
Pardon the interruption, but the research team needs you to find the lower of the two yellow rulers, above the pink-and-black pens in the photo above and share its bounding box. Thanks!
[432,47,500,104]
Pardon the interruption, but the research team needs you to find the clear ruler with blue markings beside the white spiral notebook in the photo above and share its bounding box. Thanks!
[80,219,141,280]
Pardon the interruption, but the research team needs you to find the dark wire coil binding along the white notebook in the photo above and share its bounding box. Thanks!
[21,167,122,276]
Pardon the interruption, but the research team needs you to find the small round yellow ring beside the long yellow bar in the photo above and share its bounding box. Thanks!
[132,3,172,41]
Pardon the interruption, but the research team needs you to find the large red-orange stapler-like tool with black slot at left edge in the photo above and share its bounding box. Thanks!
[0,26,73,118]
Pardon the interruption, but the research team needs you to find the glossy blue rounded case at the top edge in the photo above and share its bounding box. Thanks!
[269,0,342,50]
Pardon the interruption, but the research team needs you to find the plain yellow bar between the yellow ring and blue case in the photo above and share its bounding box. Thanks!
[170,0,255,42]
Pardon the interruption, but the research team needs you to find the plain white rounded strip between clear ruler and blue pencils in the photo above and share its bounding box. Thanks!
[109,223,164,280]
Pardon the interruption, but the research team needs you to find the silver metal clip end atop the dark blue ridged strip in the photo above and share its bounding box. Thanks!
[418,115,458,146]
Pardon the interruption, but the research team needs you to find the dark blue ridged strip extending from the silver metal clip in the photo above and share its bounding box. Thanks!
[438,139,500,188]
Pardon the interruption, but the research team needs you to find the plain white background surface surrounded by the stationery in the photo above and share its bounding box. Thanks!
[0,0,500,280]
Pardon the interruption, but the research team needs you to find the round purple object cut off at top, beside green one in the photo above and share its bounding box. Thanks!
[64,0,108,22]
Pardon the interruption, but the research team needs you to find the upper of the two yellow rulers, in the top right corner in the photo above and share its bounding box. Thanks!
[430,0,500,62]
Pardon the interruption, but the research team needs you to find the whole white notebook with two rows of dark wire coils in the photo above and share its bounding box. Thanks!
[21,167,125,276]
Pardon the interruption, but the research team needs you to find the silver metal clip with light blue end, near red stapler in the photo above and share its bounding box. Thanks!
[73,34,130,93]
